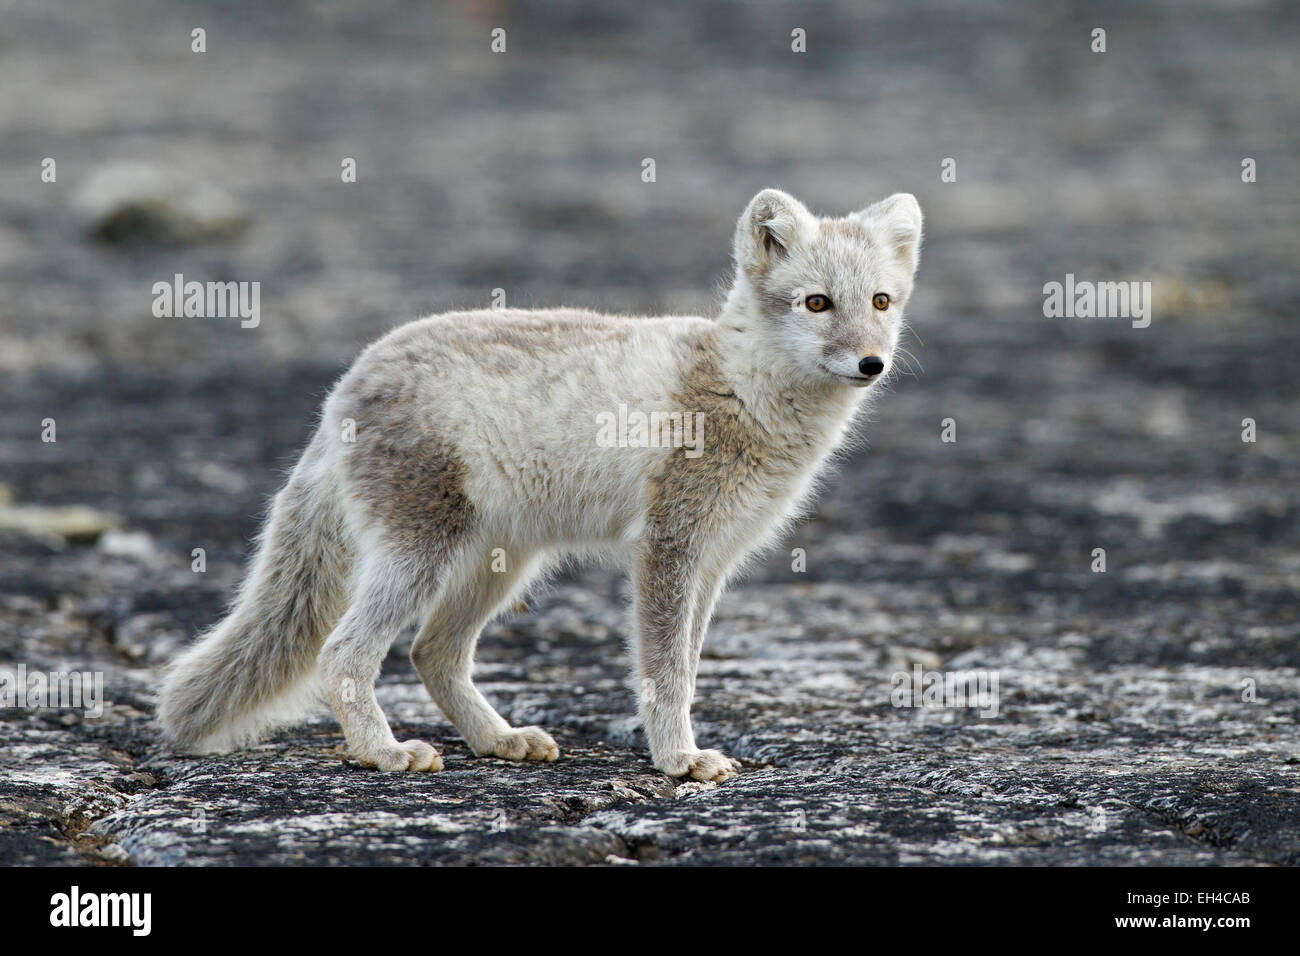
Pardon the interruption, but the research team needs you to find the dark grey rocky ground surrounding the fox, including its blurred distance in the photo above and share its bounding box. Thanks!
[0,0,1300,865]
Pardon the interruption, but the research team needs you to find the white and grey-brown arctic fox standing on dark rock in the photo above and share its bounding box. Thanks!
[159,189,922,780]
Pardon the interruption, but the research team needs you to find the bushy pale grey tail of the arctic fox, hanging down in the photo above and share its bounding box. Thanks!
[159,447,348,753]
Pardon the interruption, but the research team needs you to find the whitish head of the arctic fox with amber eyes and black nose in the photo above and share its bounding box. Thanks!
[735,189,922,388]
